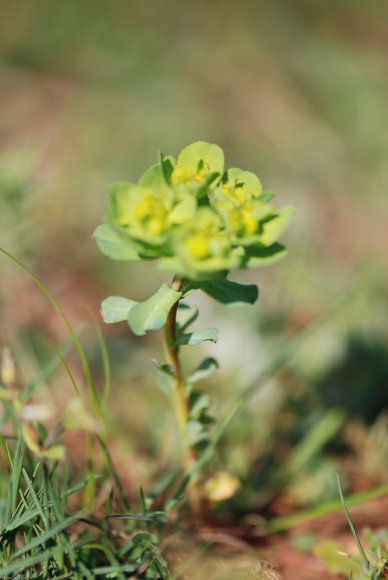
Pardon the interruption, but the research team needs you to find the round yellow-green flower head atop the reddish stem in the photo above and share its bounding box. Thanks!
[95,141,293,280]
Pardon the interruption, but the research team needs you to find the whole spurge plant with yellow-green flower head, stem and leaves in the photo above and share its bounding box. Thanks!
[94,141,294,516]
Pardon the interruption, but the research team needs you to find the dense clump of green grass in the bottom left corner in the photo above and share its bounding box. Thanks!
[0,440,169,580]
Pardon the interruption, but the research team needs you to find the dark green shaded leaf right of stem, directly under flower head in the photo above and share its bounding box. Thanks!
[189,280,259,305]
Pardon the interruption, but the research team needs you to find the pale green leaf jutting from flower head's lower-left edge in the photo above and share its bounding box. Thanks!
[93,224,140,260]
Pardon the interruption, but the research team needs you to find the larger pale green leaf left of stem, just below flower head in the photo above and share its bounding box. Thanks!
[128,283,182,336]
